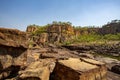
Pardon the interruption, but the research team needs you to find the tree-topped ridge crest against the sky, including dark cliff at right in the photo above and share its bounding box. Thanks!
[28,20,120,35]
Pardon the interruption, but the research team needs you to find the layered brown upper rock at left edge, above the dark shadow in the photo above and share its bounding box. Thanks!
[0,28,27,47]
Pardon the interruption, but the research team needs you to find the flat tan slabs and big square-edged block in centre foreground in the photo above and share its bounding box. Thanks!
[24,45,107,80]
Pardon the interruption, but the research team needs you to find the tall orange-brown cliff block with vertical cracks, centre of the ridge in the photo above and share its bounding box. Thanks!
[47,24,74,43]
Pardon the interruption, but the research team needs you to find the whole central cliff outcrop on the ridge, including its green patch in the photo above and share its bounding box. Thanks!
[26,24,74,45]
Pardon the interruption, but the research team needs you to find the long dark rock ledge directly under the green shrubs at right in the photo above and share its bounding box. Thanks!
[63,43,120,57]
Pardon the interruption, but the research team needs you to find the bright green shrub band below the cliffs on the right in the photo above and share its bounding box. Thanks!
[65,33,120,45]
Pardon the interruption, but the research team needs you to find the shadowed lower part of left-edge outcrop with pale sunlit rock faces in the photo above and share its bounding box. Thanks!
[0,45,27,79]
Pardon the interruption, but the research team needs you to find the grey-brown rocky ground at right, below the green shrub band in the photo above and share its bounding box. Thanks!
[63,43,120,80]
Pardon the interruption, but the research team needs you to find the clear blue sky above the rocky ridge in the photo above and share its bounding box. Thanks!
[0,0,120,30]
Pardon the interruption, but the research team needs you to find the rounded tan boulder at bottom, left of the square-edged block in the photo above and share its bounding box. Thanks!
[19,61,50,80]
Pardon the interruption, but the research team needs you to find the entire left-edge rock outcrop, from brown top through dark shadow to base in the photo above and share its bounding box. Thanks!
[0,28,27,79]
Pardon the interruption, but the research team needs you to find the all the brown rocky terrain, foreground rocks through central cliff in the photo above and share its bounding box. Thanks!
[0,25,120,80]
